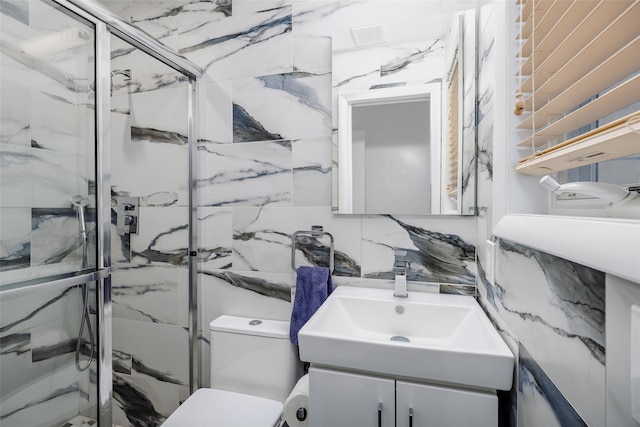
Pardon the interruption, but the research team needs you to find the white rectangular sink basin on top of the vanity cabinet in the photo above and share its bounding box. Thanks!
[298,286,514,390]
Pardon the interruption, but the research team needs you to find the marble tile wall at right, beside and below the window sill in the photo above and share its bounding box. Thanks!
[476,2,616,427]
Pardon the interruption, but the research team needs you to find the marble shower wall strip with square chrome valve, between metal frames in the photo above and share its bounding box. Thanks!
[111,33,189,426]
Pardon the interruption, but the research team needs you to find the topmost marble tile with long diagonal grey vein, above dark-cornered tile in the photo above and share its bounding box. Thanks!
[179,6,293,81]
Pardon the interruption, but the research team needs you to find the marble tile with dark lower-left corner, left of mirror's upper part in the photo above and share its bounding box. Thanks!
[233,69,331,142]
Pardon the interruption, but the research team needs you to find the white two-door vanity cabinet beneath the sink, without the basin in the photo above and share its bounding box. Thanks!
[309,366,498,427]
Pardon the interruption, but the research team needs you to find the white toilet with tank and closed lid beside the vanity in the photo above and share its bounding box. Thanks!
[162,315,302,427]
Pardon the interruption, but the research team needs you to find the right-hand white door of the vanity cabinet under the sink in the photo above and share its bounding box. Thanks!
[396,381,498,427]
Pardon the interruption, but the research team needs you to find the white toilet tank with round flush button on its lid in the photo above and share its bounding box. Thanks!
[209,315,302,403]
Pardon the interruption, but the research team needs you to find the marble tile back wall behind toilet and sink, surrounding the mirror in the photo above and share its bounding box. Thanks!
[178,1,475,398]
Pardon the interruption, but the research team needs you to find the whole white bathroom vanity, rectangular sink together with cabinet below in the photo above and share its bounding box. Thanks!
[298,286,514,427]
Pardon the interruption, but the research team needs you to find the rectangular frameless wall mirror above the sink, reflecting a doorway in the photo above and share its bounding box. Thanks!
[332,1,476,215]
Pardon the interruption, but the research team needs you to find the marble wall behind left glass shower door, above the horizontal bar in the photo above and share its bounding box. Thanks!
[0,1,95,284]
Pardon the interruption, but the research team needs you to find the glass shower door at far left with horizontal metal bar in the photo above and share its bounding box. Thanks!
[0,0,98,427]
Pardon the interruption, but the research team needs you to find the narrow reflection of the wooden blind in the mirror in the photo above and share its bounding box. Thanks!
[446,61,460,199]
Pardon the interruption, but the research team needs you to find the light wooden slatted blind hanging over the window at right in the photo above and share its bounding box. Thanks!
[515,0,640,175]
